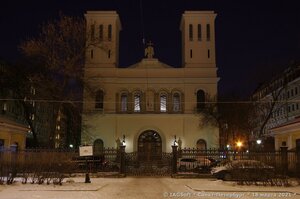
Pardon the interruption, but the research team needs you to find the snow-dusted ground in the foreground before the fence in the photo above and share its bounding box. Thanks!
[0,177,300,199]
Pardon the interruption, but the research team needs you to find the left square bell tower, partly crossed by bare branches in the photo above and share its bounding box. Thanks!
[85,11,122,68]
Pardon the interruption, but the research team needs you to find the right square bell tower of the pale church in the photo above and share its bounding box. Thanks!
[180,11,217,68]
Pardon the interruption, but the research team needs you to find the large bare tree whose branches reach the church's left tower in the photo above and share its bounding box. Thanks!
[20,14,103,146]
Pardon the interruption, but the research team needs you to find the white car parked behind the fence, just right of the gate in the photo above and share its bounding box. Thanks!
[177,157,213,172]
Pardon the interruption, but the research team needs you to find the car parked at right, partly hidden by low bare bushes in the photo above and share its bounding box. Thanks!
[211,160,275,181]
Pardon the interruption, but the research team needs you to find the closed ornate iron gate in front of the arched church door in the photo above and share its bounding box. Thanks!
[125,152,172,176]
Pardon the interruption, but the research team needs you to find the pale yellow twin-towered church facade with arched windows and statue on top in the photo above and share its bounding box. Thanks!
[81,11,219,154]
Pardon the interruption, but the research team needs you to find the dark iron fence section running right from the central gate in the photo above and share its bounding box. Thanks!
[176,148,300,176]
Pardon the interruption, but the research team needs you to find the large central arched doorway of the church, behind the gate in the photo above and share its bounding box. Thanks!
[138,130,162,162]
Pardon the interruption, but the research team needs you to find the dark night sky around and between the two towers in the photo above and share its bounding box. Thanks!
[0,0,300,96]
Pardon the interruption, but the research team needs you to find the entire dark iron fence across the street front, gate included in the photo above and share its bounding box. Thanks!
[0,146,300,179]
